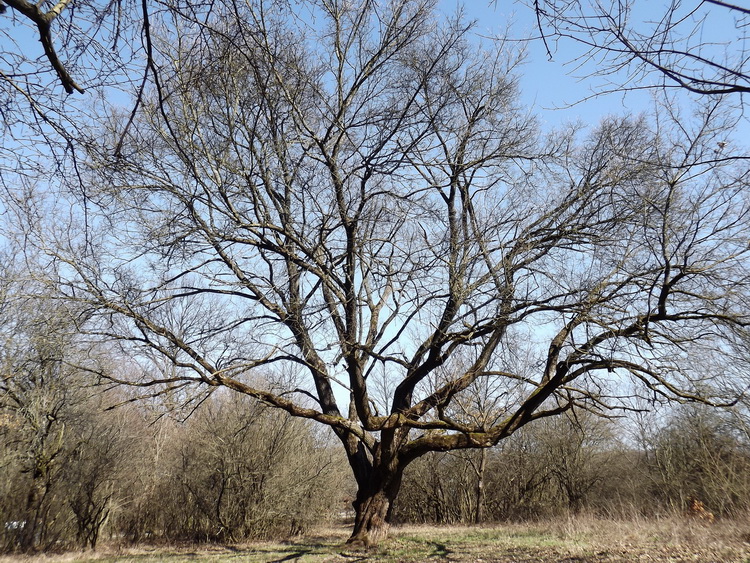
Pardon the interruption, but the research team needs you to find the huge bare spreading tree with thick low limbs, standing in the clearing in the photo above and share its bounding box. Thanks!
[39,0,750,544]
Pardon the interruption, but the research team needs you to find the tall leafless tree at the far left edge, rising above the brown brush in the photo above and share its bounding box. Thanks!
[0,256,137,551]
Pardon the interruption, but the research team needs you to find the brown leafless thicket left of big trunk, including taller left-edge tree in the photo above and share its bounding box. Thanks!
[0,270,348,552]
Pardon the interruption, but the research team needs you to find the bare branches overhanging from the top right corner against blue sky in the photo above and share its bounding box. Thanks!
[525,0,750,95]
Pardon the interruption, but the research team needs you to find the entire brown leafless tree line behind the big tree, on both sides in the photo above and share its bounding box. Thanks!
[5,316,750,552]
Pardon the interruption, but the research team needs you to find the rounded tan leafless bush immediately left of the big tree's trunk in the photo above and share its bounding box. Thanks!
[167,396,348,541]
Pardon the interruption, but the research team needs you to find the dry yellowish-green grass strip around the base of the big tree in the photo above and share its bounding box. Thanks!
[0,517,750,563]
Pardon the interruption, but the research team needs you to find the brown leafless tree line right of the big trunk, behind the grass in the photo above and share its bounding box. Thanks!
[396,405,750,524]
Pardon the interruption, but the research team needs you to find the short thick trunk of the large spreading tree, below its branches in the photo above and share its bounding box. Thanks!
[346,469,402,547]
